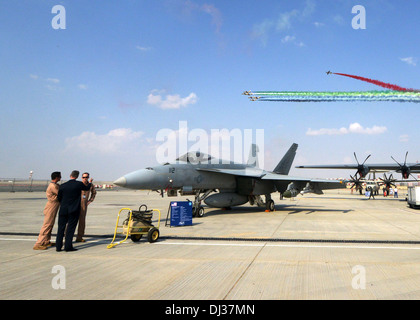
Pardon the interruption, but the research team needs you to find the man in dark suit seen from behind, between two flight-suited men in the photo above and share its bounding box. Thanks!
[55,170,93,251]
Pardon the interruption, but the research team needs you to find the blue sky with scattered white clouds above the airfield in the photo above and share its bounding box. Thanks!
[0,0,420,180]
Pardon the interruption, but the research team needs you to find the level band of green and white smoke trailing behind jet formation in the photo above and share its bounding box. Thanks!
[251,91,420,103]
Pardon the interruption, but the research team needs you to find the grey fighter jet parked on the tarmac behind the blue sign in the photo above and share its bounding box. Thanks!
[114,143,345,216]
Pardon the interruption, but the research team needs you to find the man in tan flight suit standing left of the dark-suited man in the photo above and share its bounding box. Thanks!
[34,171,61,250]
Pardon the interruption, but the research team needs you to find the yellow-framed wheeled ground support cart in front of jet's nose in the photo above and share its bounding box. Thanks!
[107,204,160,249]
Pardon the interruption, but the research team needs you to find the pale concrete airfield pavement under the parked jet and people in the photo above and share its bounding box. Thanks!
[0,190,420,300]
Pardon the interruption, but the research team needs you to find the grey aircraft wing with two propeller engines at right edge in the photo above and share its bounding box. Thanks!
[296,151,420,180]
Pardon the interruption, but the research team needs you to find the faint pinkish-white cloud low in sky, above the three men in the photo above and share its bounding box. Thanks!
[65,128,143,155]
